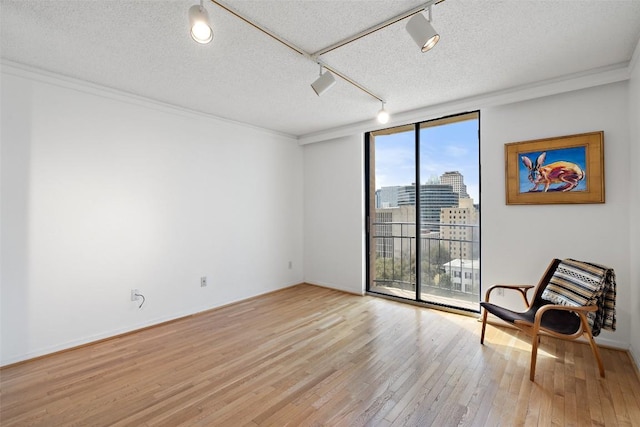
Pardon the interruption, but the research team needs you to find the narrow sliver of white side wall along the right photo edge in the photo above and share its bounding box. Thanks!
[629,48,640,367]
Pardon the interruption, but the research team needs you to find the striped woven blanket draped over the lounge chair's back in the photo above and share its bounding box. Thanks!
[542,259,616,336]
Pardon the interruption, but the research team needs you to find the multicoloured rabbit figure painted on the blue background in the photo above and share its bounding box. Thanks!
[522,151,584,193]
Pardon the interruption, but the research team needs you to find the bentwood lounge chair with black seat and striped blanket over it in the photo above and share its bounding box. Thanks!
[480,259,615,381]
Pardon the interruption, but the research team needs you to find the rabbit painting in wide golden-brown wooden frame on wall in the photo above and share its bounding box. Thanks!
[504,131,604,205]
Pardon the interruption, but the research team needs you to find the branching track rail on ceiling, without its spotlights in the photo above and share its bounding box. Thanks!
[209,0,444,104]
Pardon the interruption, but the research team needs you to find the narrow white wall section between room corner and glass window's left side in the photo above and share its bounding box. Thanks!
[304,135,364,294]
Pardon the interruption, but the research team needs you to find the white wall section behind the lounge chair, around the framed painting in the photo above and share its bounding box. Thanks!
[481,82,631,348]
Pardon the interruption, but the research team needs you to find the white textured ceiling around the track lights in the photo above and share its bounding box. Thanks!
[0,0,640,136]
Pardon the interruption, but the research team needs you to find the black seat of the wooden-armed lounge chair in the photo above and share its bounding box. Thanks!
[480,302,580,335]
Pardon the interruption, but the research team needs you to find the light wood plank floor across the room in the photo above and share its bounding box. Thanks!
[0,285,640,427]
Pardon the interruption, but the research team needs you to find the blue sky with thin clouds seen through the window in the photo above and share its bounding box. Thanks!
[375,120,480,203]
